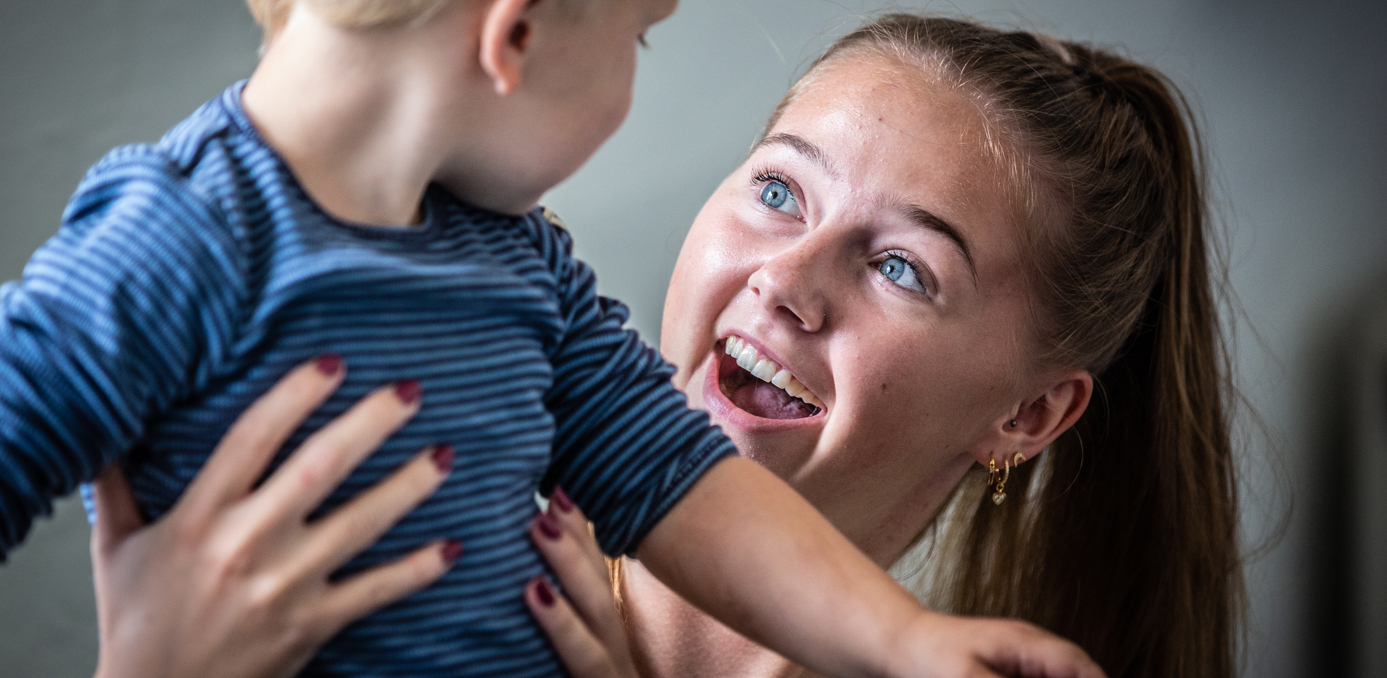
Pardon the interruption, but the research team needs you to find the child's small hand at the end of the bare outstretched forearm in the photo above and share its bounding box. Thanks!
[892,611,1104,678]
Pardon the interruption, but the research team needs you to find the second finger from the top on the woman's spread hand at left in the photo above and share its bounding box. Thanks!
[257,381,420,516]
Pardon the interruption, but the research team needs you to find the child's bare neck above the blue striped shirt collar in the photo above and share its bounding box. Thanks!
[241,10,449,226]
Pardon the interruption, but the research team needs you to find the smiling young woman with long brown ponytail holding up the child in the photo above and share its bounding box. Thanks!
[86,15,1243,677]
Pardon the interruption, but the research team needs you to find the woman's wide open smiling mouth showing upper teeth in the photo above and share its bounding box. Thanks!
[717,336,824,419]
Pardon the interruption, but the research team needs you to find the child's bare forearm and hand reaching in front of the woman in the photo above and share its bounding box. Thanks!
[637,458,1103,677]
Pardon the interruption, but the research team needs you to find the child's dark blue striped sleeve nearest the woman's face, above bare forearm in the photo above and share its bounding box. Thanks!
[542,216,736,556]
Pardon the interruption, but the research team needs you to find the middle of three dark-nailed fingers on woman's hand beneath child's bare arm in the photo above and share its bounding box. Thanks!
[530,513,626,647]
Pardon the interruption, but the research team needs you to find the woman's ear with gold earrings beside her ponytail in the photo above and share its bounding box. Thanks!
[974,370,1093,467]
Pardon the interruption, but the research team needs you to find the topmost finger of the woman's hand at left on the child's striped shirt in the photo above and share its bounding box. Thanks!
[182,355,347,509]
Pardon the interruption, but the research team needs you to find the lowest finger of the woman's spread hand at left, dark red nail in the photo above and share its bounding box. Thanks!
[315,542,462,635]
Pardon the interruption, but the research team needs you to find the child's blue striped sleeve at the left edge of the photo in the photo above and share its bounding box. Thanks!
[0,147,240,560]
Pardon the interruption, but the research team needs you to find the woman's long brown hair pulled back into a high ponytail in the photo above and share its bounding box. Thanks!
[804,15,1244,677]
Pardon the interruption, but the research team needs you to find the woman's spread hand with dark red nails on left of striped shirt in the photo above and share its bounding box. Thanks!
[92,358,460,678]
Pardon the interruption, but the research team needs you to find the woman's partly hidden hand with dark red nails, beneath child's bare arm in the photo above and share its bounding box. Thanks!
[524,488,637,678]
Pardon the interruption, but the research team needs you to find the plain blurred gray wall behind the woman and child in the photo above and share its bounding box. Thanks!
[0,0,1387,677]
